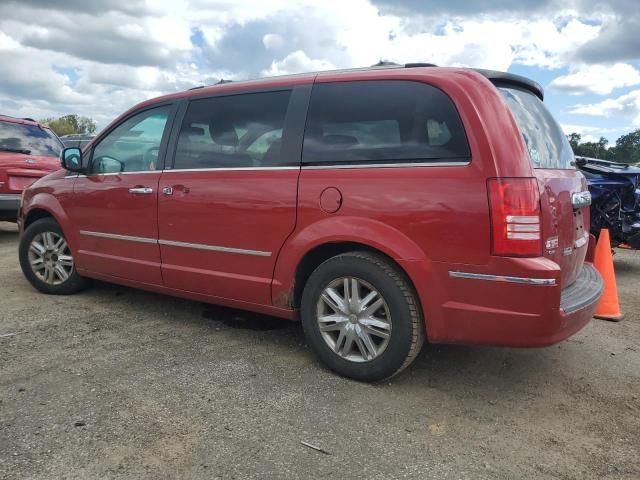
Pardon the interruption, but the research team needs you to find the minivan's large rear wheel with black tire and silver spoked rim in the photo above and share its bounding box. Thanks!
[301,252,424,382]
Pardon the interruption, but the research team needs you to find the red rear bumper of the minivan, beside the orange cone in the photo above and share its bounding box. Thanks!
[404,259,603,347]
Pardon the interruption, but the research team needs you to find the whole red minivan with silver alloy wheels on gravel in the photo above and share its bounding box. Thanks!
[19,65,602,381]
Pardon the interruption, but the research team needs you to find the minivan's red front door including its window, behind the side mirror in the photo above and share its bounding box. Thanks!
[68,105,172,285]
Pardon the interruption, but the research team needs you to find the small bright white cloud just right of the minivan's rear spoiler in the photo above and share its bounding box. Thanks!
[549,63,640,95]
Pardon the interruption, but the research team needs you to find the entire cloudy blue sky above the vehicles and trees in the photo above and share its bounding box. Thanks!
[0,0,640,143]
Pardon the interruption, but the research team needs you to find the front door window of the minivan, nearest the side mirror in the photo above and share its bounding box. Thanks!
[90,106,171,174]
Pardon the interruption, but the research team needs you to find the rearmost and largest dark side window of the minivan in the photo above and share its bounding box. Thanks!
[302,80,471,165]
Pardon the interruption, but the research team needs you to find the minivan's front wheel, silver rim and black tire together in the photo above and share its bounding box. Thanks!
[18,218,86,295]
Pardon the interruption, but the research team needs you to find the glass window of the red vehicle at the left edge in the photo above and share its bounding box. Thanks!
[0,122,62,157]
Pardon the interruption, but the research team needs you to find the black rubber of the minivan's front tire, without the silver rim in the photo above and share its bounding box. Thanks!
[18,217,86,295]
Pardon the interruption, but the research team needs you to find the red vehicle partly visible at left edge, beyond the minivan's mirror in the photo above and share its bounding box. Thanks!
[0,115,63,222]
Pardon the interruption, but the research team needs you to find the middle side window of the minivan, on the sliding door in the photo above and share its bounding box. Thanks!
[174,90,291,169]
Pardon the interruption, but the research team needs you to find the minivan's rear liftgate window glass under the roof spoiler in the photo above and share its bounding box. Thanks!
[499,88,575,169]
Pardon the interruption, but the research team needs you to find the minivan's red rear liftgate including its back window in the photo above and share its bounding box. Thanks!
[499,88,590,288]
